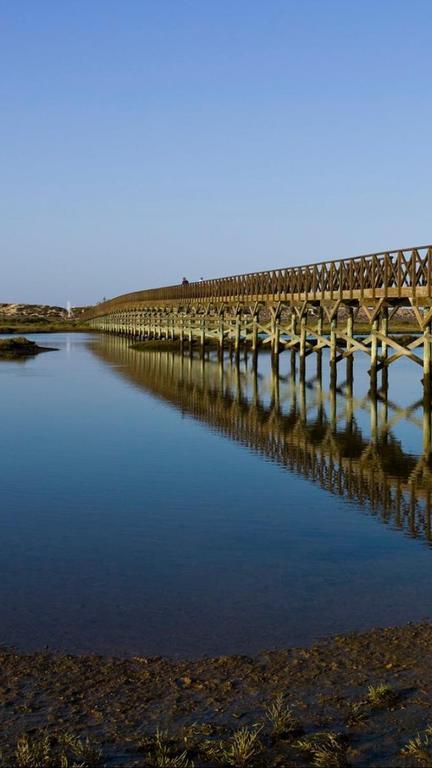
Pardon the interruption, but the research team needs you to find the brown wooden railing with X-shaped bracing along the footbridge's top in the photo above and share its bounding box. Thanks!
[92,245,432,315]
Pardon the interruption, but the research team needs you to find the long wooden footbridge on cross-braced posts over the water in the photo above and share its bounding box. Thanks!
[88,245,432,389]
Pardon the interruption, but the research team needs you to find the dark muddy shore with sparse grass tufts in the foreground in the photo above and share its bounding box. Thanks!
[0,623,432,768]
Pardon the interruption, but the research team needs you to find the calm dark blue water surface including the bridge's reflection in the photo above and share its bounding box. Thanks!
[0,334,432,656]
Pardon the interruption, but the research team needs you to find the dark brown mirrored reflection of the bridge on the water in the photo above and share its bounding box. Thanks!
[92,335,432,542]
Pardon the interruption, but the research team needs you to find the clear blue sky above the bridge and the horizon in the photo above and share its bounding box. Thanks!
[0,0,432,304]
